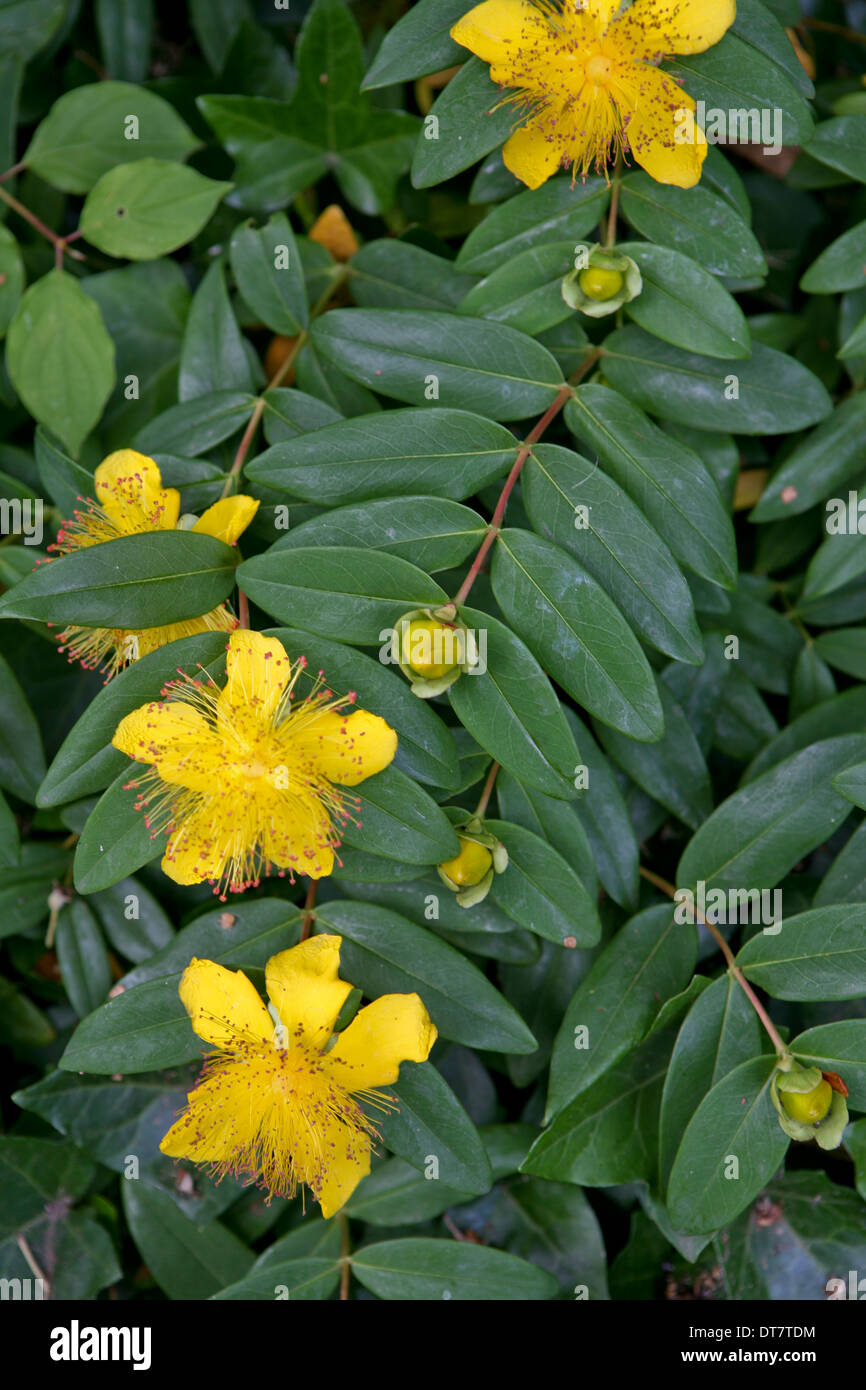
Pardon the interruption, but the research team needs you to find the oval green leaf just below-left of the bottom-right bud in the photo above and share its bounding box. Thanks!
[667,1056,788,1232]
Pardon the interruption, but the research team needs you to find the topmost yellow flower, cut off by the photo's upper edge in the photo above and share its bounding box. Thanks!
[450,0,737,188]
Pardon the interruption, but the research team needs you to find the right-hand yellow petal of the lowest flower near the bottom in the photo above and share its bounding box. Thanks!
[325,994,436,1091]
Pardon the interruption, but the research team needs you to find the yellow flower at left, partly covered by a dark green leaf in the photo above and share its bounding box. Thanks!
[49,449,259,680]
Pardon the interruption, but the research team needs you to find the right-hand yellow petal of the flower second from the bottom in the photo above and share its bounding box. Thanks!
[282,709,398,787]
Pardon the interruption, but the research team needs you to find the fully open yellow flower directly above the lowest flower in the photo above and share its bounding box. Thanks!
[113,628,398,901]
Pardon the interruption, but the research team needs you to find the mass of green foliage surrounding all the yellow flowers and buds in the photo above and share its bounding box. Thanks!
[0,0,866,1300]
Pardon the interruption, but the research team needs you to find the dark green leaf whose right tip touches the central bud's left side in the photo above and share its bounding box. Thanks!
[240,546,448,644]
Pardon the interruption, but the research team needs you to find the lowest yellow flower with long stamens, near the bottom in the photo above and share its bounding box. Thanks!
[160,935,436,1216]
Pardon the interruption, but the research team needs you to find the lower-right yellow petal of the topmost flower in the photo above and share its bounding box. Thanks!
[626,67,706,188]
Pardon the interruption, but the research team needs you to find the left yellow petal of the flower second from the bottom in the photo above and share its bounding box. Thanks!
[111,701,221,791]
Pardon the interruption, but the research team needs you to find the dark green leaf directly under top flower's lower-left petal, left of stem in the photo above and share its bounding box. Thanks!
[457,177,610,275]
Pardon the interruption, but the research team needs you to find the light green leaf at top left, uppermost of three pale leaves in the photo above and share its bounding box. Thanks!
[24,82,200,193]
